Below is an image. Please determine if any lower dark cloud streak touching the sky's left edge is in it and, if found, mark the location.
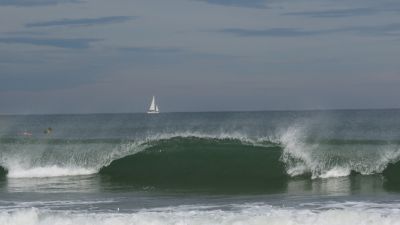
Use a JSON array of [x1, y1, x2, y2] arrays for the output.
[[0, 37, 100, 49]]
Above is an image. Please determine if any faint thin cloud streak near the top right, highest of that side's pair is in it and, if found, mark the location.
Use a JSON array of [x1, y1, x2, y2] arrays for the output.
[[283, 8, 379, 18]]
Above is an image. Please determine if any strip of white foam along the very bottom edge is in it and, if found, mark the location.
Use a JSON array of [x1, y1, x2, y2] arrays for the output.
[[0, 205, 400, 225]]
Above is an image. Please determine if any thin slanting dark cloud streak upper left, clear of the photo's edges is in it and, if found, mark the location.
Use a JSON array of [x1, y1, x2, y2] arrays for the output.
[[25, 16, 134, 27]]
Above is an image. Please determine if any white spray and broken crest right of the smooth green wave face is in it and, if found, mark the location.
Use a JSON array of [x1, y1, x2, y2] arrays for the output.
[[280, 127, 400, 179]]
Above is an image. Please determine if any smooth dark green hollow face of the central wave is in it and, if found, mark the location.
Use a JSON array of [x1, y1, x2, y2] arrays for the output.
[[100, 138, 288, 189]]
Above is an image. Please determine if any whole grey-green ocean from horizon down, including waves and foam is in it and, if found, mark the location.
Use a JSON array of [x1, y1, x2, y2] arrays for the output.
[[0, 110, 400, 225]]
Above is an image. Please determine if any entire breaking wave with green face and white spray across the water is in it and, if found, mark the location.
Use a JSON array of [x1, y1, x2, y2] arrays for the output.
[[0, 127, 400, 187]]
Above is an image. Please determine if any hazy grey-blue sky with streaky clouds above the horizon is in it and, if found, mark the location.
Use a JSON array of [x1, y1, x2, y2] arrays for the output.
[[0, 0, 400, 114]]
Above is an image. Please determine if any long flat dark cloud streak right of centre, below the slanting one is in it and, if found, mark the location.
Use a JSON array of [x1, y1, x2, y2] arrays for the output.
[[219, 28, 327, 37]]
